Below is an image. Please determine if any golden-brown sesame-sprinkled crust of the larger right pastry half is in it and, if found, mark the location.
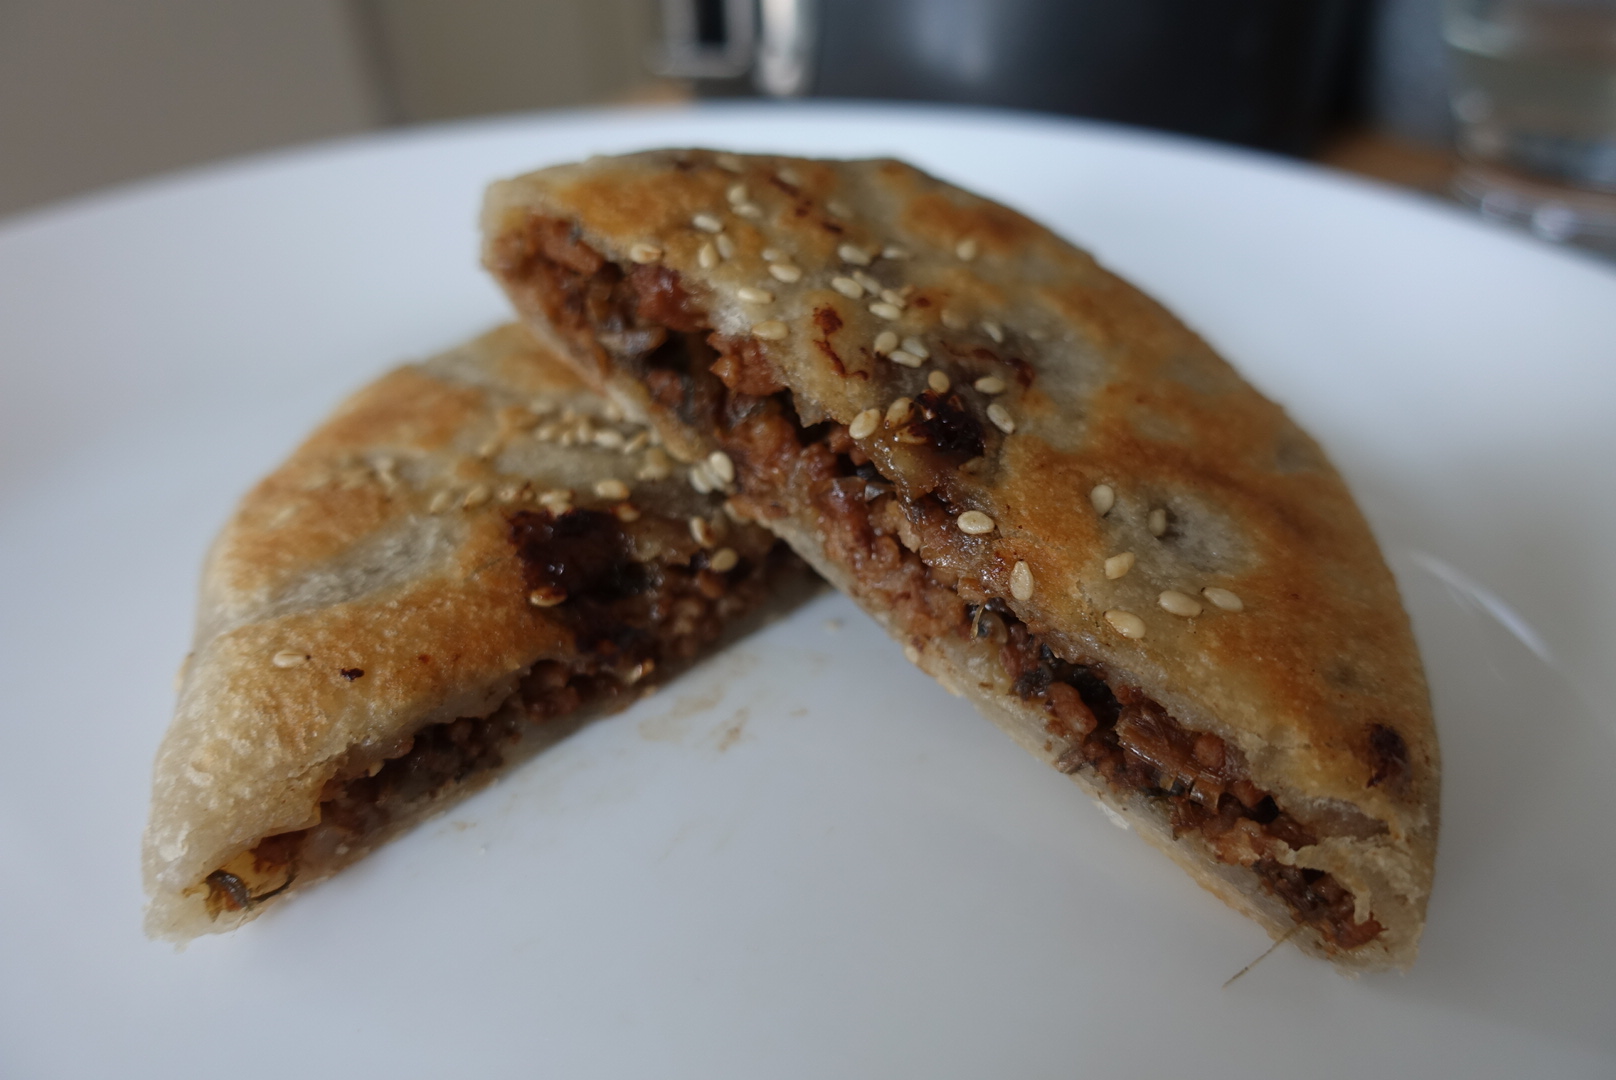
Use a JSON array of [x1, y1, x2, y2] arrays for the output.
[[483, 150, 1438, 967]]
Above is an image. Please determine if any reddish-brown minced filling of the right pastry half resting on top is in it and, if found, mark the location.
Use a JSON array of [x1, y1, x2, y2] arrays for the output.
[[493, 218, 1383, 951]]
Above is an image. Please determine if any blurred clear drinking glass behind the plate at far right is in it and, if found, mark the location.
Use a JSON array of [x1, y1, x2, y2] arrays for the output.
[[1443, 0, 1616, 255]]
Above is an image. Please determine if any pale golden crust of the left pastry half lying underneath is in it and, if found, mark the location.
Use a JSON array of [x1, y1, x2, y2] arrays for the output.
[[144, 327, 795, 939]]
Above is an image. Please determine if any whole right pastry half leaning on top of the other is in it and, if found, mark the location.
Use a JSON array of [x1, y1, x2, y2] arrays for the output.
[[483, 150, 1438, 968]]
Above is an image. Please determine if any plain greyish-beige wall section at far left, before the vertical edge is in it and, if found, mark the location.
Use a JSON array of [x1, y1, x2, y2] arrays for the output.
[[0, 0, 380, 213]]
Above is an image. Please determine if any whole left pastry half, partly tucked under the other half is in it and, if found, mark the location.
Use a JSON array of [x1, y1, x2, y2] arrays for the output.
[[144, 327, 811, 939]]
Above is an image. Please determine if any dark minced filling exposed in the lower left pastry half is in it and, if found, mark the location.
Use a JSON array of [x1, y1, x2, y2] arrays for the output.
[[204, 508, 800, 917]]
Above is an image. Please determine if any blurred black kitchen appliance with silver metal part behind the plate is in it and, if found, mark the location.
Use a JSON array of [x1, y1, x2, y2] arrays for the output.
[[663, 0, 1372, 154]]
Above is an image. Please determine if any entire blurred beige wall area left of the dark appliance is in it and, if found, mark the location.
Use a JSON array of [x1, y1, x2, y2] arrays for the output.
[[0, 0, 669, 215]]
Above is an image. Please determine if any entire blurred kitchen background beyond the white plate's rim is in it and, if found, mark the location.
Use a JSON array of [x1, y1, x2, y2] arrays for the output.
[[0, 0, 1616, 251]]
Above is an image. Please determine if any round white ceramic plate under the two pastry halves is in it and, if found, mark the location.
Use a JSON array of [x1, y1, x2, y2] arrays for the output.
[[0, 108, 1616, 1080]]
